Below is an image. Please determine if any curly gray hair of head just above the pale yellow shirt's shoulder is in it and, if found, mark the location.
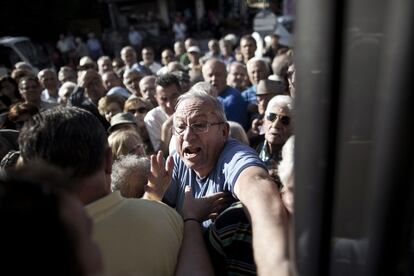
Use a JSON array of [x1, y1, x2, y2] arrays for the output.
[[111, 154, 151, 195]]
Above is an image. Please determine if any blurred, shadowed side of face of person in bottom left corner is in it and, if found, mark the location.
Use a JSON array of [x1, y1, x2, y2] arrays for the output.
[[60, 195, 103, 275]]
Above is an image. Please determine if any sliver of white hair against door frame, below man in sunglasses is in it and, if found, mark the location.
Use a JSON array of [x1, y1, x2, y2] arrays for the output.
[[277, 136, 295, 185]]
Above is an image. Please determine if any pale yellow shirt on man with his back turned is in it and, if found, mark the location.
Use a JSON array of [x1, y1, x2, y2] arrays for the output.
[[85, 191, 183, 276]]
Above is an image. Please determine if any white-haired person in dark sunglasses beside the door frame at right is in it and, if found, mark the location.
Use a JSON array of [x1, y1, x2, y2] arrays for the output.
[[255, 95, 293, 185]]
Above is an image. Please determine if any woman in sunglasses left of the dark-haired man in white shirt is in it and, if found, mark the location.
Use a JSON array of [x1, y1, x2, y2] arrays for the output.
[[124, 96, 154, 155]]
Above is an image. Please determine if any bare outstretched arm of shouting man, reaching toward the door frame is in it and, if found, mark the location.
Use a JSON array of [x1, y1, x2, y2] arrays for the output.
[[234, 166, 289, 275]]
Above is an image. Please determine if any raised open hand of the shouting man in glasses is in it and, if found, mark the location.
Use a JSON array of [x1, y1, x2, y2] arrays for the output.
[[143, 151, 174, 201]]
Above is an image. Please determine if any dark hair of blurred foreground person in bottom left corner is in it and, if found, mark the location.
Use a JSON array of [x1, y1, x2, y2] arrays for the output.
[[0, 166, 82, 276]]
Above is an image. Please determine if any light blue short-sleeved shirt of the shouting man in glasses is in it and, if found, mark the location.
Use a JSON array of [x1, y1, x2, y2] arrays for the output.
[[164, 138, 266, 226]]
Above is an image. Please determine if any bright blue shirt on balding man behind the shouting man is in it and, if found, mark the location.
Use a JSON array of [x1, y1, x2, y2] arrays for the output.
[[217, 86, 250, 130]]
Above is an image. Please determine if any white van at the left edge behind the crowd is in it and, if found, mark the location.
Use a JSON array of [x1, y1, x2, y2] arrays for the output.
[[0, 36, 52, 76]]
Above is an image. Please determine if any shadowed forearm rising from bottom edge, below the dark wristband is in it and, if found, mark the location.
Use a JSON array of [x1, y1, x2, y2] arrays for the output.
[[175, 220, 214, 276]]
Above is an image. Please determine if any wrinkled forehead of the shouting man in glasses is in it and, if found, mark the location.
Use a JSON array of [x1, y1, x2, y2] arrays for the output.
[[174, 99, 216, 121]]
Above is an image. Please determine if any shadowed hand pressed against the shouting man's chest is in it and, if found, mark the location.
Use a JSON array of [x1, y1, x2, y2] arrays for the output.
[[183, 186, 231, 221]]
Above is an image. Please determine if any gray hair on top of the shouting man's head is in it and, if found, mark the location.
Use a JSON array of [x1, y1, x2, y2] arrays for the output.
[[175, 85, 227, 122]]
